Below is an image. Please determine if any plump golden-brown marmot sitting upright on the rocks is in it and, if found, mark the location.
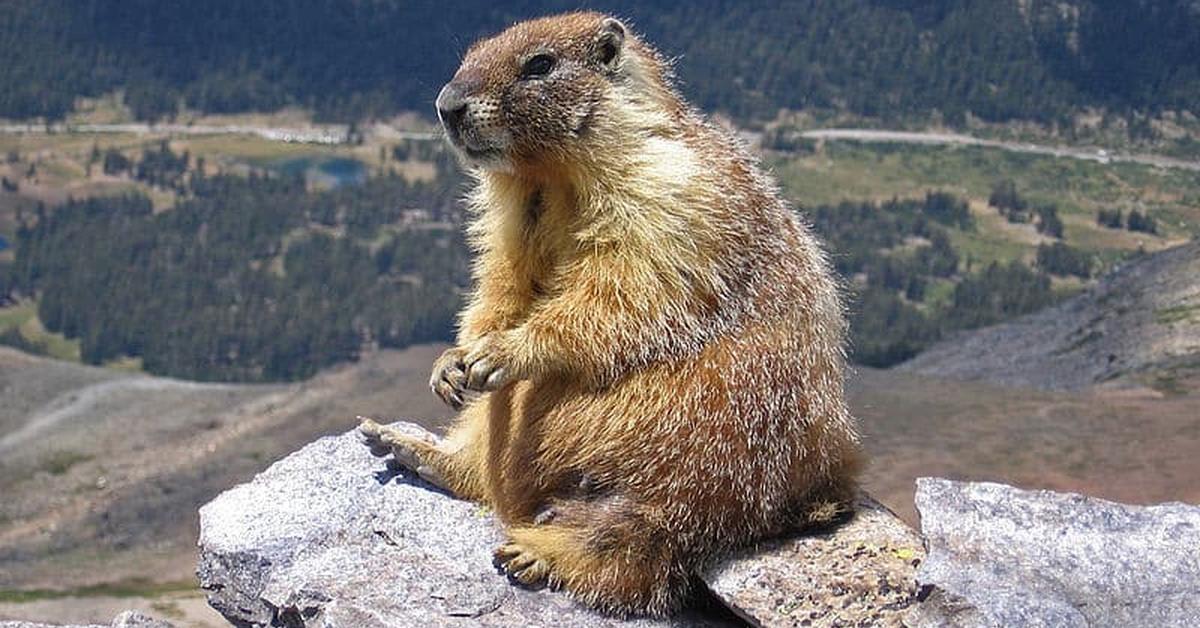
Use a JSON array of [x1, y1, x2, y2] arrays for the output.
[[362, 12, 860, 615]]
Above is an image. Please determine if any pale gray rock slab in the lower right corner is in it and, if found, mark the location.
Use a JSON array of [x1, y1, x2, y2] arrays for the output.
[[907, 478, 1200, 628]]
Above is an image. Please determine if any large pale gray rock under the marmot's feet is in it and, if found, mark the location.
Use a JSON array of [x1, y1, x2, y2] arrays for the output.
[[198, 425, 721, 628]]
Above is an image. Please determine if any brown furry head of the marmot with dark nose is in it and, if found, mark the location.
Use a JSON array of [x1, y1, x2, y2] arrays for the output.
[[437, 13, 677, 169]]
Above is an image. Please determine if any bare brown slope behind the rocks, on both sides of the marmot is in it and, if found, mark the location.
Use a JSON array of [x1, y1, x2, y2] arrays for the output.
[[0, 338, 1200, 626]]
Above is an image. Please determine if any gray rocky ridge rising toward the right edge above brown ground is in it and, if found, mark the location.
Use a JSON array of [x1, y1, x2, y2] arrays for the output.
[[898, 241, 1200, 390]]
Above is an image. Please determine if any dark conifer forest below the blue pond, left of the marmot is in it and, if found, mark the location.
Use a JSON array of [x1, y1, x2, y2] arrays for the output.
[[8, 146, 469, 382]]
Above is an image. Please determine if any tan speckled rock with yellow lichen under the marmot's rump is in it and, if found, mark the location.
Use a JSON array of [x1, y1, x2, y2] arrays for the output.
[[703, 497, 925, 627]]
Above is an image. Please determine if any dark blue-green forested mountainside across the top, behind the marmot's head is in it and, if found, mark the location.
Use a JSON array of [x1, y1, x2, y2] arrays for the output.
[[0, 0, 1200, 122]]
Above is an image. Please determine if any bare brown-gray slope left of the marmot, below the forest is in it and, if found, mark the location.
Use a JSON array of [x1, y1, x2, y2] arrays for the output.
[[0, 346, 449, 590]]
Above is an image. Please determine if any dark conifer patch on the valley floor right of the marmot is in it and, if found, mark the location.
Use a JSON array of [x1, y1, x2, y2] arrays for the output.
[[806, 192, 1069, 367]]
